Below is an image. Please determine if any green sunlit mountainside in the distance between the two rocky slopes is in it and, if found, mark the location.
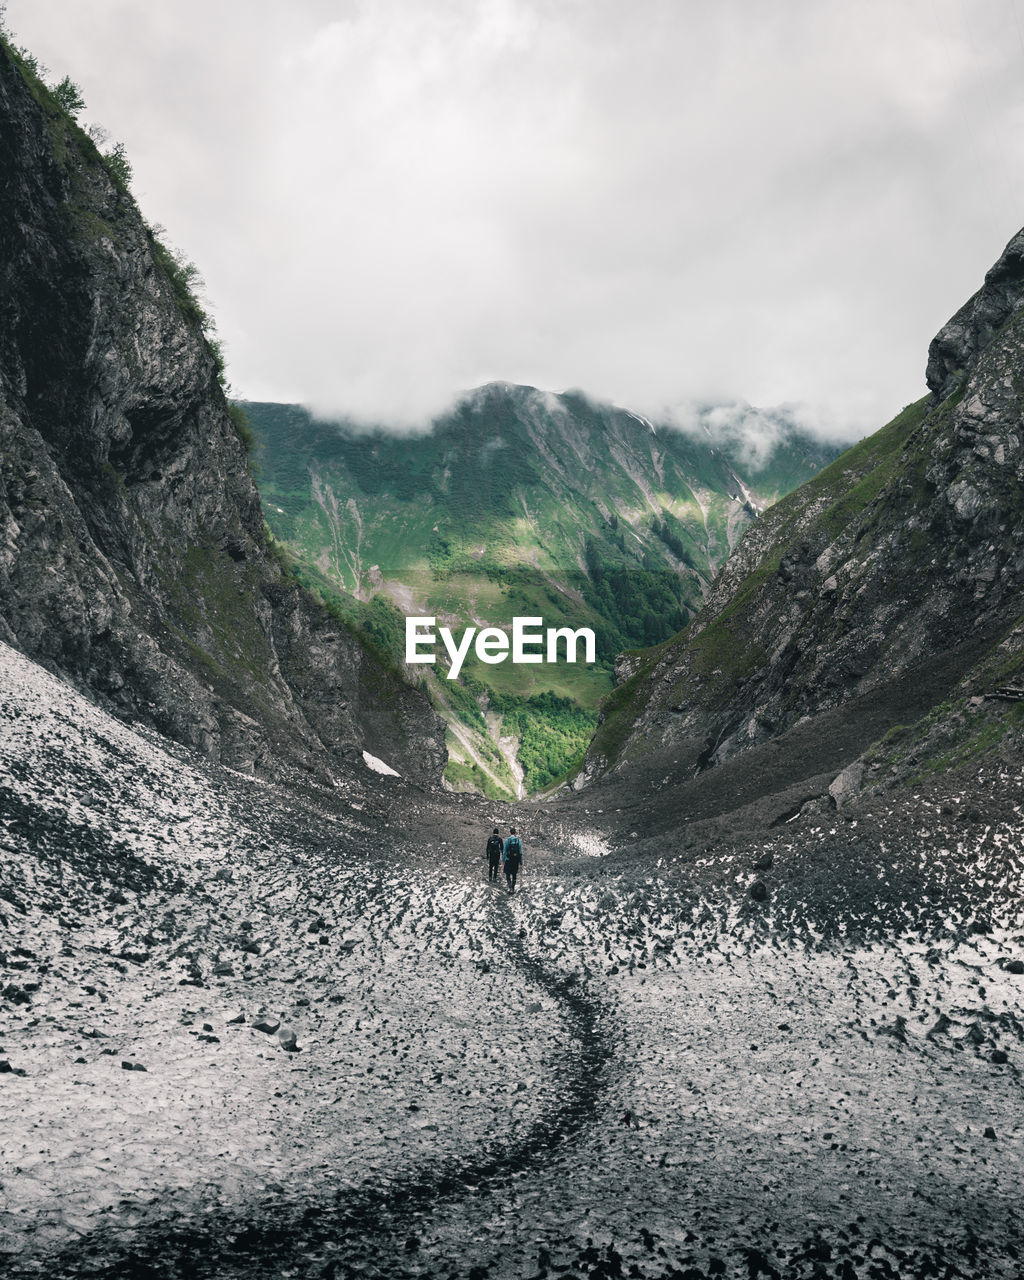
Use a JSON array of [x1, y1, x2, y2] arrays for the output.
[[244, 384, 838, 794]]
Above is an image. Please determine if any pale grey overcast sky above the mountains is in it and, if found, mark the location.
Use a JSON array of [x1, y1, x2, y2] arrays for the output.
[[6, 0, 1024, 435]]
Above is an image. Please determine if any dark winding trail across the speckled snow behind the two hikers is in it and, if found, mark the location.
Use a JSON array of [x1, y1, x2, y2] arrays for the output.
[[32, 880, 616, 1280]]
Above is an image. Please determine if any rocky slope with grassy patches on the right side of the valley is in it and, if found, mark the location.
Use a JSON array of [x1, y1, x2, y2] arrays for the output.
[[582, 218, 1024, 787]]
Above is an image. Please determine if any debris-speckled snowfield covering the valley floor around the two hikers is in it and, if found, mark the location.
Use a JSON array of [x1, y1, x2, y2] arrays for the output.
[[0, 645, 1024, 1280]]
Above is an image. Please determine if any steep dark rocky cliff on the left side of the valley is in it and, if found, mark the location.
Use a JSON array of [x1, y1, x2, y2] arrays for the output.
[[0, 47, 445, 781]]
